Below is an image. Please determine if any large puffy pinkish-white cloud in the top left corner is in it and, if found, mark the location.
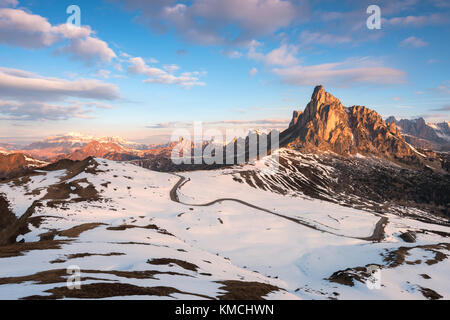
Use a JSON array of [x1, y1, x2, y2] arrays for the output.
[[0, 8, 116, 64]]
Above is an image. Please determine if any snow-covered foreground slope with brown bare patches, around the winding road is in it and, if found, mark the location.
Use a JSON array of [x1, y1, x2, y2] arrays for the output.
[[0, 159, 450, 299]]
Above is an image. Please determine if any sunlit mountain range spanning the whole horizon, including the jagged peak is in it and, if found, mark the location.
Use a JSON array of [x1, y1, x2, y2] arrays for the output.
[[0, 86, 450, 178]]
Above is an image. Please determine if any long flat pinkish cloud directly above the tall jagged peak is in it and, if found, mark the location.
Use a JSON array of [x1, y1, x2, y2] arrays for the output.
[[273, 58, 406, 87]]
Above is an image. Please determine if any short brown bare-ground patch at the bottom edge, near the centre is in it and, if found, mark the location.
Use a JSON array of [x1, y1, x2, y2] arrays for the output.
[[217, 280, 282, 300]]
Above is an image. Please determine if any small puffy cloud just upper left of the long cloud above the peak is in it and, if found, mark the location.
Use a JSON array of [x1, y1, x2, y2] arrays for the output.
[[247, 43, 299, 66]]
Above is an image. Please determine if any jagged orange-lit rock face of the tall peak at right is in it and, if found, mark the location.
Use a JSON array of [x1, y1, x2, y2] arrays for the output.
[[280, 86, 419, 162]]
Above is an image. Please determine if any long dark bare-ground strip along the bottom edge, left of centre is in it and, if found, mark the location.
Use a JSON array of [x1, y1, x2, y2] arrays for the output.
[[24, 283, 213, 300]]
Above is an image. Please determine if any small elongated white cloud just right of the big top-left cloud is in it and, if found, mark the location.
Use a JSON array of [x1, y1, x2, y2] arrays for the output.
[[128, 57, 206, 88]]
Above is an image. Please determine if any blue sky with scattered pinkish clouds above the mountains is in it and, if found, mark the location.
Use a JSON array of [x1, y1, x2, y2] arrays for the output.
[[0, 0, 450, 143]]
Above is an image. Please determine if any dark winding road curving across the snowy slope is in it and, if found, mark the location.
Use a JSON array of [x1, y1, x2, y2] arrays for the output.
[[170, 173, 389, 242]]
